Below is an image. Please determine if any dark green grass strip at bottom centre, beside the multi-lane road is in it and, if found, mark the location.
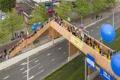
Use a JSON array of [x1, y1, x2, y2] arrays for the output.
[[44, 55, 84, 80]]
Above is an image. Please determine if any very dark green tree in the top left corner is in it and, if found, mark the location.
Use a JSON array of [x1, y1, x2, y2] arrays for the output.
[[0, 0, 16, 12]]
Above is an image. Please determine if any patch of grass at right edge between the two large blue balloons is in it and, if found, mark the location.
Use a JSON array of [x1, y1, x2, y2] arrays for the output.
[[106, 28, 120, 51]]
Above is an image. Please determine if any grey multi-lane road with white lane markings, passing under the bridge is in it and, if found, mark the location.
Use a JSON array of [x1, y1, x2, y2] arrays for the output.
[[0, 41, 68, 80]]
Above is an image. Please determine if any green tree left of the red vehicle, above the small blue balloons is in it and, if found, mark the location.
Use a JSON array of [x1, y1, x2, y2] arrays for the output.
[[28, 4, 48, 24]]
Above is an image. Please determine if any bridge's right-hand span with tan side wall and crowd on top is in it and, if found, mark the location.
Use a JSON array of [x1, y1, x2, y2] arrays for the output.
[[50, 18, 120, 80]]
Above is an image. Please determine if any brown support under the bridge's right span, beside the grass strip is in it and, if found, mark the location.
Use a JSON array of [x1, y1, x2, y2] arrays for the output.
[[68, 42, 80, 61]]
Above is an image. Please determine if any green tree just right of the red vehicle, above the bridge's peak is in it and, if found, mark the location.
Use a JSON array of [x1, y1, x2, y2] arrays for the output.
[[55, 0, 72, 19]]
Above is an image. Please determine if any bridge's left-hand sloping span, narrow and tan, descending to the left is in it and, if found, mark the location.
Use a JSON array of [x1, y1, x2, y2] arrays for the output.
[[9, 20, 50, 58]]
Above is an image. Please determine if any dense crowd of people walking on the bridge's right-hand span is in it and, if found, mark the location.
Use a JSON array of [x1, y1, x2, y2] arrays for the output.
[[55, 16, 114, 59]]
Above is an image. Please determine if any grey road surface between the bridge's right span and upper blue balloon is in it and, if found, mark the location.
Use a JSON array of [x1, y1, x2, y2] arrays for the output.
[[86, 13, 120, 40]]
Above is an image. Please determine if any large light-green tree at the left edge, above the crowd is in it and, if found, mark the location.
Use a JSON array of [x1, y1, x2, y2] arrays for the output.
[[1, 9, 23, 32]]
